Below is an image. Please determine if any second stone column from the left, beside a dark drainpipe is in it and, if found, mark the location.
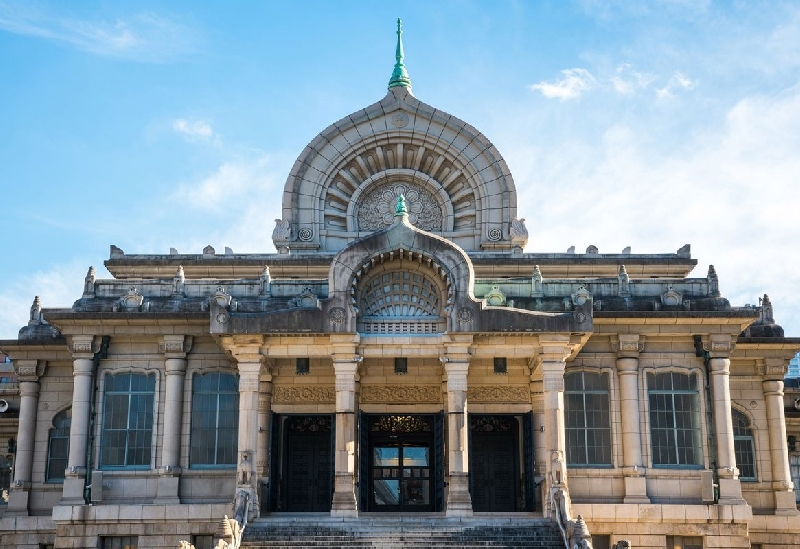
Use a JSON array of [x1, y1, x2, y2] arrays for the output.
[[60, 335, 94, 505]]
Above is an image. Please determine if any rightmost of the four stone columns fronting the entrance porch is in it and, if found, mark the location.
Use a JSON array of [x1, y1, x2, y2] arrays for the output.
[[539, 335, 570, 512]]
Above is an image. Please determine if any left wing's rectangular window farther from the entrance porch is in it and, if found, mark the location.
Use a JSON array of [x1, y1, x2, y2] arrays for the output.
[[100, 373, 156, 468]]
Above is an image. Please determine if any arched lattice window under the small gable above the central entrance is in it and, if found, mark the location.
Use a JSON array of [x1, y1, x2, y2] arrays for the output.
[[356, 262, 446, 334]]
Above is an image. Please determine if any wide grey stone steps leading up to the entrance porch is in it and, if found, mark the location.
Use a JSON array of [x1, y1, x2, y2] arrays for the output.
[[241, 516, 564, 549]]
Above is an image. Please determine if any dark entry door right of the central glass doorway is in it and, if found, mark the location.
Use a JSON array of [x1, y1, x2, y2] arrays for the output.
[[469, 418, 519, 512]]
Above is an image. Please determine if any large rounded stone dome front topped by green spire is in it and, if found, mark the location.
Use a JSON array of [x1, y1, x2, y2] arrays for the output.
[[273, 21, 527, 252]]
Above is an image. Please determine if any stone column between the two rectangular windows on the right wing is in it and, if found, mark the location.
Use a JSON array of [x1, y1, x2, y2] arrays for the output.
[[611, 334, 650, 503]]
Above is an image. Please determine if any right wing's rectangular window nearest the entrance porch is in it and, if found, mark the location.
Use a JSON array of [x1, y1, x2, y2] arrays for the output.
[[564, 372, 611, 466]]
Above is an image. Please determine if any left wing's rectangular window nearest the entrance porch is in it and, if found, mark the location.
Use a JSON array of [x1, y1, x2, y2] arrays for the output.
[[189, 372, 239, 467]]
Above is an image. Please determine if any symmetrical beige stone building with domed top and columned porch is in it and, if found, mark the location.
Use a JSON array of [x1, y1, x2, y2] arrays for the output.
[[0, 23, 800, 549]]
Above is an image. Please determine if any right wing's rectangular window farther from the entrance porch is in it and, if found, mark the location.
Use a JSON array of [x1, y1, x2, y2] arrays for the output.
[[647, 372, 703, 467]]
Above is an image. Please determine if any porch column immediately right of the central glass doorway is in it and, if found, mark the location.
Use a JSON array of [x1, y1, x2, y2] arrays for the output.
[[442, 354, 472, 517]]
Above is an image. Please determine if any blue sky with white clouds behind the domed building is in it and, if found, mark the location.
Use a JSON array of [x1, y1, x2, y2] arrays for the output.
[[0, 0, 800, 339]]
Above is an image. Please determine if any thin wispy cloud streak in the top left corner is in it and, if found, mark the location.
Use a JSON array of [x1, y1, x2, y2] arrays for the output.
[[0, 2, 196, 63]]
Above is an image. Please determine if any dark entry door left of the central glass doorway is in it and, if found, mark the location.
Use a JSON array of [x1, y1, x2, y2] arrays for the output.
[[284, 418, 333, 513]]
